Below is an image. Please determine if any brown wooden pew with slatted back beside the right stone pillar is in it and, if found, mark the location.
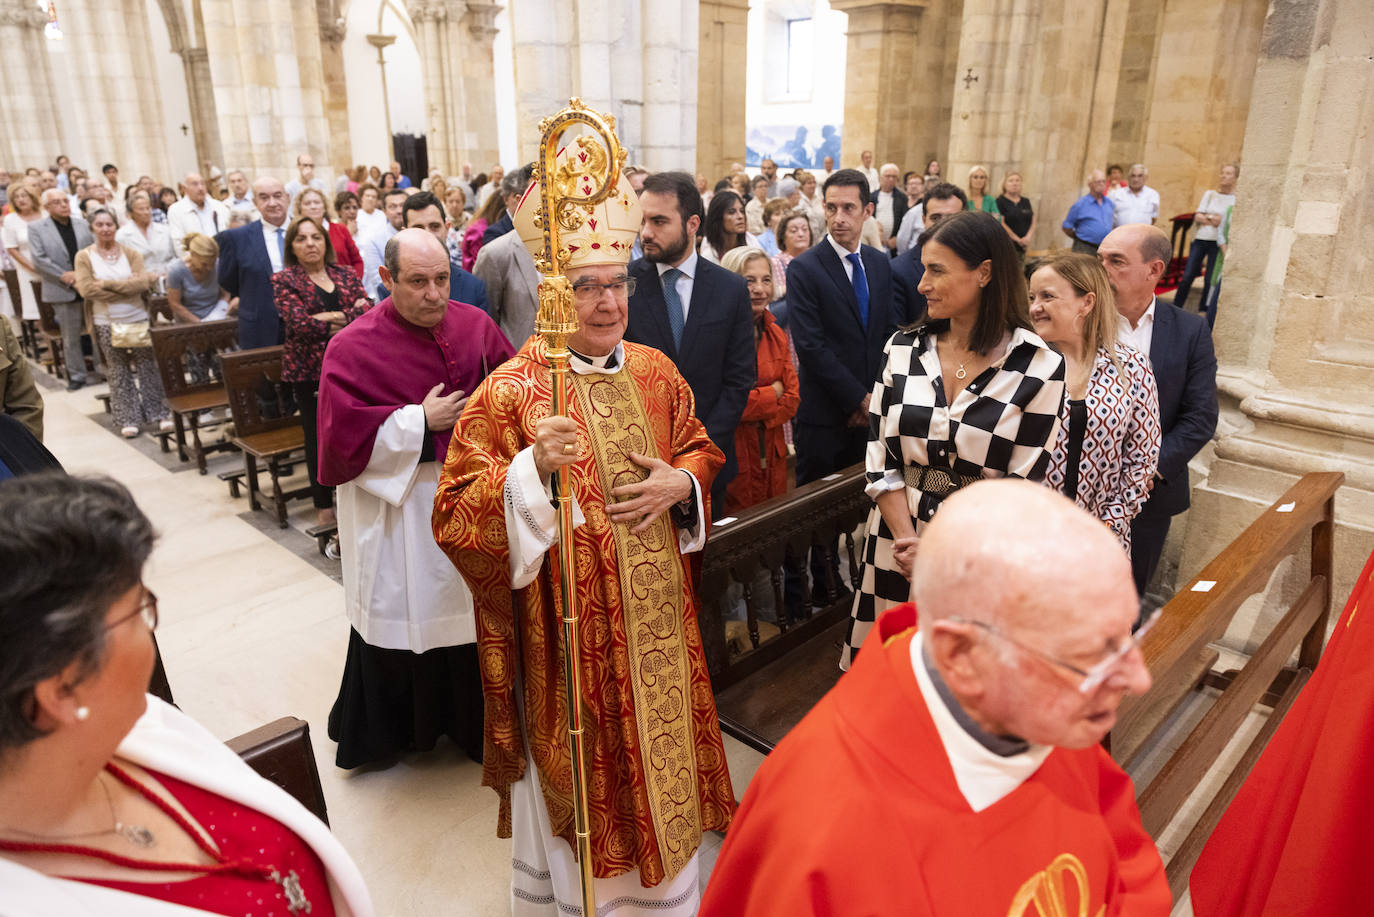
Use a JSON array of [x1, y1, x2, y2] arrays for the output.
[[1112, 473, 1345, 898]]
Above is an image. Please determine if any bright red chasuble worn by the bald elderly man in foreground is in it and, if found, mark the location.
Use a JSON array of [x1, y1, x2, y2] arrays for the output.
[[699, 602, 1171, 917]]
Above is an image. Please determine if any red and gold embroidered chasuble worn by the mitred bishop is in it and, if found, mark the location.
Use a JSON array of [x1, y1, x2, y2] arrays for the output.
[[434, 337, 734, 887]]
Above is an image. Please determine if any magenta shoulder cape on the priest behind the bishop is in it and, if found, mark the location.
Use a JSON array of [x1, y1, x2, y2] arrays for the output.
[[319, 297, 514, 487]]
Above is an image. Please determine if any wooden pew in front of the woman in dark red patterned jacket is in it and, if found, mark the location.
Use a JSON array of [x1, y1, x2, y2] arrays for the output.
[[220, 345, 309, 528]]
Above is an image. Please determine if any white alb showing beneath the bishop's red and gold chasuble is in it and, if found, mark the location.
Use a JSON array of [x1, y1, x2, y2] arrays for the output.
[[506, 344, 706, 917]]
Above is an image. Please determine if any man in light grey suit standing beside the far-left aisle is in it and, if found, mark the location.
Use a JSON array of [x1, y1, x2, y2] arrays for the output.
[[29, 188, 99, 392]]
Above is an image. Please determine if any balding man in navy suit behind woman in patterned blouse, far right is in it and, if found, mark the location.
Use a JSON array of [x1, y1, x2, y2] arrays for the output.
[[1098, 224, 1217, 595]]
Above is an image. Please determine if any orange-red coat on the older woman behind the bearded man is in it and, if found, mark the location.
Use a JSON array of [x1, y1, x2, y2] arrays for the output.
[[725, 311, 801, 513]]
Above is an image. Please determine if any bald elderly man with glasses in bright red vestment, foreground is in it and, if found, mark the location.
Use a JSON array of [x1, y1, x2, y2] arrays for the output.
[[701, 480, 1171, 917]]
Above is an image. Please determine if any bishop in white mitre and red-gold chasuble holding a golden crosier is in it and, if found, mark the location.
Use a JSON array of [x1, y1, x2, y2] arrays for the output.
[[434, 150, 734, 917]]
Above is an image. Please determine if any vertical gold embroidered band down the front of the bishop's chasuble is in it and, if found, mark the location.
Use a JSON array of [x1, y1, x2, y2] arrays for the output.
[[573, 368, 702, 876]]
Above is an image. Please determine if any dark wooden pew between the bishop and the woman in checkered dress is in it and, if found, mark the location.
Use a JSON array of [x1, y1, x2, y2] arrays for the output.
[[698, 465, 872, 753]]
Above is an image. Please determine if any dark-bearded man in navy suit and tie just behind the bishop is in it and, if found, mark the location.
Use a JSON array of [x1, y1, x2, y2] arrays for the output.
[[625, 172, 758, 518]]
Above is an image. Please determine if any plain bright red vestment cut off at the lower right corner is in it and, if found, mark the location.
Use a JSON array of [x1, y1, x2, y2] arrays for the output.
[[1189, 557, 1374, 917]]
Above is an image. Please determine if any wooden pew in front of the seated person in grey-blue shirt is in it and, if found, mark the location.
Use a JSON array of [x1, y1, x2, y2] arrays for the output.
[[151, 318, 239, 474]]
